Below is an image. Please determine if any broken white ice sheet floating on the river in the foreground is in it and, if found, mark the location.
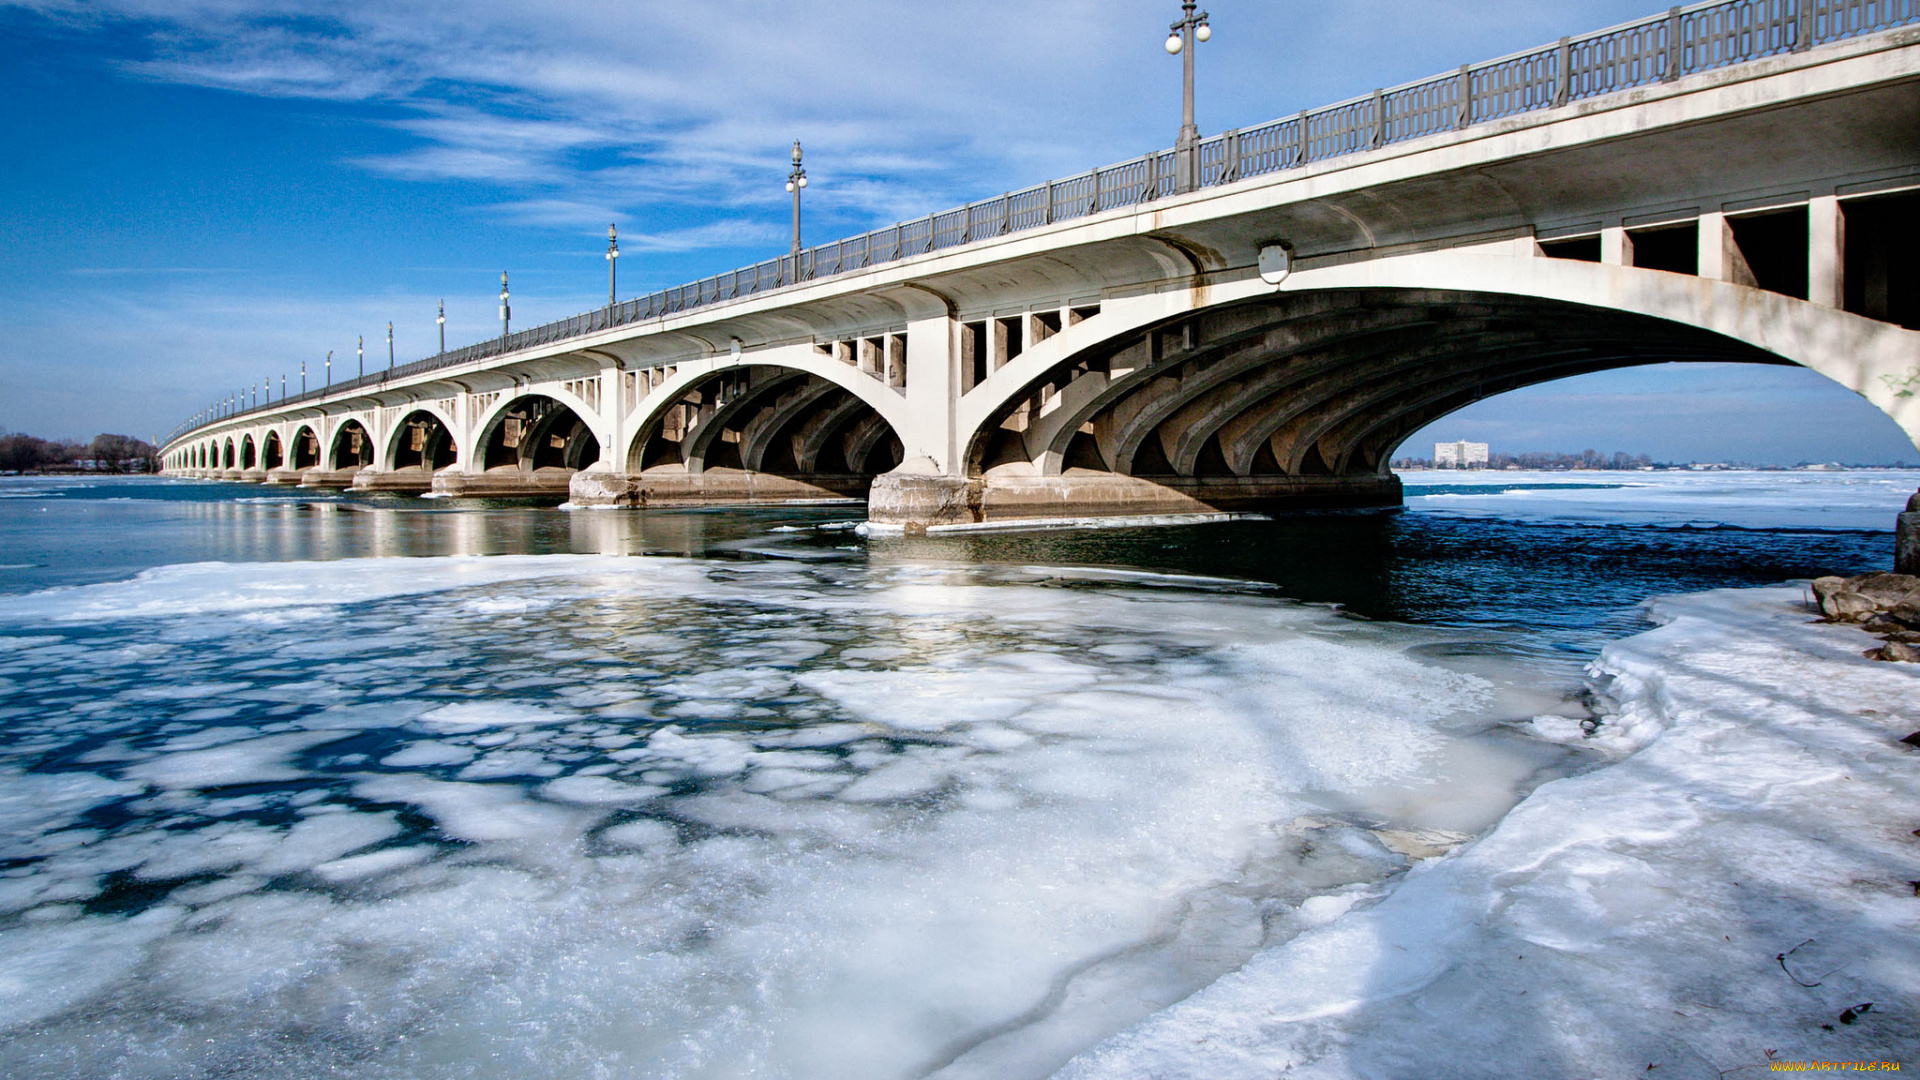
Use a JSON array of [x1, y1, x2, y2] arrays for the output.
[[0, 557, 1589, 1080]]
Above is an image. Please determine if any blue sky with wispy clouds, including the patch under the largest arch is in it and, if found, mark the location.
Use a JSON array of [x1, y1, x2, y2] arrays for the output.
[[0, 0, 1920, 463]]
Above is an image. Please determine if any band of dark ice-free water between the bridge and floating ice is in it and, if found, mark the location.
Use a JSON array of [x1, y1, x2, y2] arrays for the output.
[[0, 479, 1903, 653]]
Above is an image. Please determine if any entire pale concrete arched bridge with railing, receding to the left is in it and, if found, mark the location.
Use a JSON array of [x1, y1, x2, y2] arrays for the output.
[[163, 0, 1920, 527]]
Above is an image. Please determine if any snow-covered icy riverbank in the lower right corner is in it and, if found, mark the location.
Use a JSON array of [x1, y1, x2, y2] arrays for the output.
[[1060, 588, 1920, 1080]]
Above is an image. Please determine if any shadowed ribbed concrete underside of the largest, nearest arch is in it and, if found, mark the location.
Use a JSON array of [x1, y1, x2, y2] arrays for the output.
[[966, 288, 1789, 484]]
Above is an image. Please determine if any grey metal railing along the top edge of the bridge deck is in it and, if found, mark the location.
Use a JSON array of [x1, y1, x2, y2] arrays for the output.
[[167, 0, 1920, 444]]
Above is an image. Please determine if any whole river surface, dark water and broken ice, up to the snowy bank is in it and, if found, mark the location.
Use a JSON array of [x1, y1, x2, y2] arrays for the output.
[[0, 473, 1920, 1078]]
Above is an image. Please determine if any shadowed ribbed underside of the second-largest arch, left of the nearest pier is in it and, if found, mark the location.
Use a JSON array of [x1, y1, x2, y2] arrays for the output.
[[626, 365, 902, 494]]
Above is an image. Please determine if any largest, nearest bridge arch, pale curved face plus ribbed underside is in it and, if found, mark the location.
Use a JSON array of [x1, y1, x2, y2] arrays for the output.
[[962, 252, 1920, 486]]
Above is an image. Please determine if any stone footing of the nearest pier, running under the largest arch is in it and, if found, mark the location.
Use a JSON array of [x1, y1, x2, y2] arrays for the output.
[[866, 465, 1402, 530]]
